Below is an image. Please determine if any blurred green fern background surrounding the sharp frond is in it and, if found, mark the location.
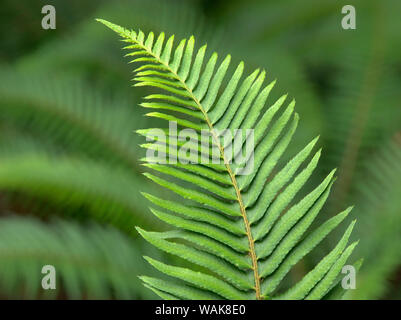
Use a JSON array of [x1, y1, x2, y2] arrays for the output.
[[0, 0, 401, 299]]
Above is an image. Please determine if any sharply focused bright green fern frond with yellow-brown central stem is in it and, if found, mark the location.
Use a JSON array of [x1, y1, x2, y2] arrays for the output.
[[98, 19, 357, 300]]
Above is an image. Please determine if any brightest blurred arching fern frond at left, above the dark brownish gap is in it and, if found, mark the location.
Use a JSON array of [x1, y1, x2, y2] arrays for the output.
[[0, 151, 156, 233]]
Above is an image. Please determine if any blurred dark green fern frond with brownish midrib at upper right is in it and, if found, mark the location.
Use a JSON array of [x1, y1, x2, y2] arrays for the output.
[[325, 2, 401, 212]]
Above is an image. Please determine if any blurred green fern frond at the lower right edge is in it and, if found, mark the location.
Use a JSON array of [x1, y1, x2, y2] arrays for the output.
[[347, 138, 401, 299]]
